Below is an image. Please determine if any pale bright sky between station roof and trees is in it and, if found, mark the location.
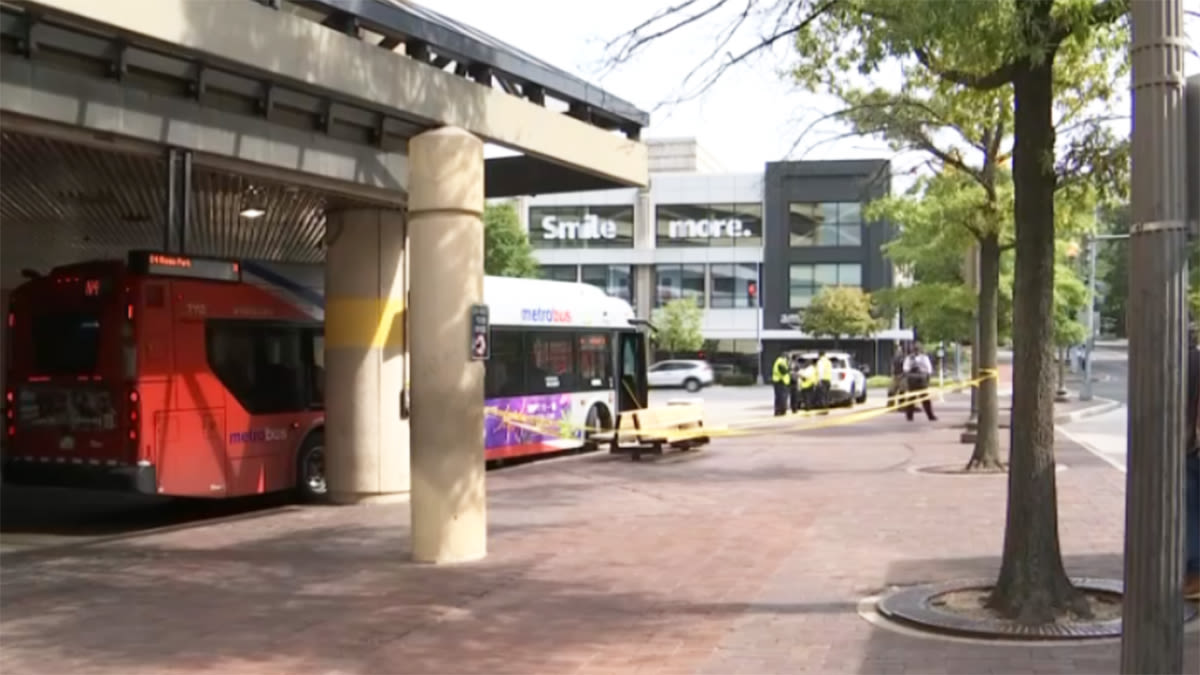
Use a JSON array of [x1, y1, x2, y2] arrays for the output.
[[436, 0, 1200, 181]]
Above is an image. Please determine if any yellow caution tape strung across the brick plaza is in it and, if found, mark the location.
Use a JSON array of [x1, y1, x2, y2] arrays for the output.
[[484, 369, 1000, 442]]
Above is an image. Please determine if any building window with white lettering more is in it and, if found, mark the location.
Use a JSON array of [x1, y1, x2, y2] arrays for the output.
[[655, 203, 762, 247]]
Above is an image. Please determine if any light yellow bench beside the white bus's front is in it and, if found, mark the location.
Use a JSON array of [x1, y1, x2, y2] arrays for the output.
[[592, 404, 709, 461]]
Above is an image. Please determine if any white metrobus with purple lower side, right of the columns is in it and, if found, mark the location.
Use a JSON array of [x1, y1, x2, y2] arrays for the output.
[[242, 262, 647, 461]]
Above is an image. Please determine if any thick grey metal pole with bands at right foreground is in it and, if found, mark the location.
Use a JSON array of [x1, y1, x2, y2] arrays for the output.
[[1121, 0, 1187, 674]]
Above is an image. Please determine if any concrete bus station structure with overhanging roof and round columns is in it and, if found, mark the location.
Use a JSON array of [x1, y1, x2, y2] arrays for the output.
[[0, 0, 648, 562]]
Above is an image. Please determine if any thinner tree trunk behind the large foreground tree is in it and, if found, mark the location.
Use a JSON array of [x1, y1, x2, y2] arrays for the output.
[[967, 234, 1004, 471]]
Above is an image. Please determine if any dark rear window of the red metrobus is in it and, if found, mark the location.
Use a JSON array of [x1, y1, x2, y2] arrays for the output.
[[30, 311, 101, 375]]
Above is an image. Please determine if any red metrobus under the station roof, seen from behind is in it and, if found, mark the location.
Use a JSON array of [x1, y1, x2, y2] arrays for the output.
[[4, 251, 325, 497]]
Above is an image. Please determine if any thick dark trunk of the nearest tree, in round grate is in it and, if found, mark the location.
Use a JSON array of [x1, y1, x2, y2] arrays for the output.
[[989, 48, 1088, 625]]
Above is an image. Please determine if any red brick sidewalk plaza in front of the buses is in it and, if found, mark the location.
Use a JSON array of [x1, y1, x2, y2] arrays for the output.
[[0, 416, 1200, 674]]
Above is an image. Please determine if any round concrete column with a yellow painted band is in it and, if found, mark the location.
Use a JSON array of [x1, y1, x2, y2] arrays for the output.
[[325, 209, 409, 503]]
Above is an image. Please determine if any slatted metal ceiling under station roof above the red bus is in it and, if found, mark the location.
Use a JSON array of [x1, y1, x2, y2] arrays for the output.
[[0, 131, 346, 287]]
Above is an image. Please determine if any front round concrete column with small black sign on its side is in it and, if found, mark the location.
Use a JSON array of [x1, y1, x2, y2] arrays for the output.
[[408, 127, 487, 562]]
